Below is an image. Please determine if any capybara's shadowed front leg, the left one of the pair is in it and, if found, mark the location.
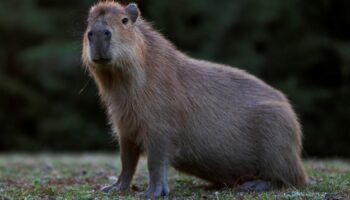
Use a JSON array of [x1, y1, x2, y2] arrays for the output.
[[102, 137, 141, 192]]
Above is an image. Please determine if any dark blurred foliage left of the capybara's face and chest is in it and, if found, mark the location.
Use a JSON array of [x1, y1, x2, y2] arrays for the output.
[[0, 0, 110, 150]]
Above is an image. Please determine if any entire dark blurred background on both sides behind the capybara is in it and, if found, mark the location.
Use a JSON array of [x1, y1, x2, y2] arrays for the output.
[[0, 0, 350, 157]]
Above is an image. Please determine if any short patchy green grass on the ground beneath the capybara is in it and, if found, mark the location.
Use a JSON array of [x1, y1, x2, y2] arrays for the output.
[[0, 154, 350, 200]]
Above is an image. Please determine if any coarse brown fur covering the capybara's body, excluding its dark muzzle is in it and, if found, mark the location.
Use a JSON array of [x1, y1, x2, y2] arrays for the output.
[[83, 2, 307, 196]]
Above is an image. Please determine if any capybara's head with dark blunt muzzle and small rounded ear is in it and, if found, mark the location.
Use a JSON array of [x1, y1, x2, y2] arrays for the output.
[[83, 1, 142, 67]]
